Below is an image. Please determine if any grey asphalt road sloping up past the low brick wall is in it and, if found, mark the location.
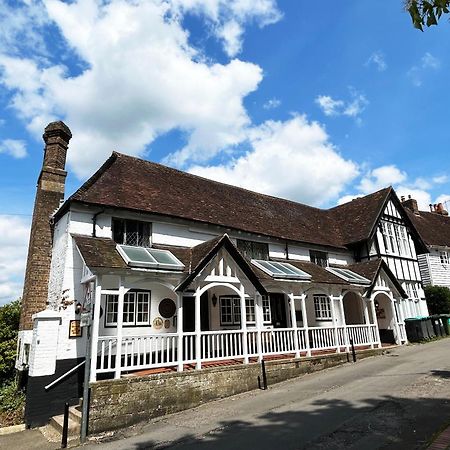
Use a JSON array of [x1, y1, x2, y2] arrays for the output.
[[82, 339, 450, 450]]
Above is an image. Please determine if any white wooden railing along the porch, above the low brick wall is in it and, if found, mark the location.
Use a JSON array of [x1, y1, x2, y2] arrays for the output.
[[96, 324, 382, 374]]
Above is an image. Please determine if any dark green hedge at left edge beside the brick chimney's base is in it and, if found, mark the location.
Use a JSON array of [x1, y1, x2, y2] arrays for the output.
[[0, 300, 20, 386]]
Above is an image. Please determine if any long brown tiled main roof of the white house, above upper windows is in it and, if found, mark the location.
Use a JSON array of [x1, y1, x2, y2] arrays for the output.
[[61, 152, 391, 248]]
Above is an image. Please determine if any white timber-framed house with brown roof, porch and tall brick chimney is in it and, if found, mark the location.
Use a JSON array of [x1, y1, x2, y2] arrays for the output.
[[17, 122, 428, 426]]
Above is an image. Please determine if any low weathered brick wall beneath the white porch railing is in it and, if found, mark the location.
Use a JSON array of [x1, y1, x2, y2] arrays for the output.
[[89, 349, 383, 434]]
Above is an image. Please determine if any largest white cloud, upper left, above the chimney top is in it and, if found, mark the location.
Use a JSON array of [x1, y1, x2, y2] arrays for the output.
[[0, 0, 275, 177]]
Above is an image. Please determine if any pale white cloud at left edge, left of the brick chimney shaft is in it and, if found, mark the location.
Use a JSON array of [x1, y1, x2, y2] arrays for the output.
[[0, 216, 29, 305]]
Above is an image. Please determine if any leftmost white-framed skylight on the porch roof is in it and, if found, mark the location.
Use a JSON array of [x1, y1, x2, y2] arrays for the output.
[[117, 245, 184, 270]]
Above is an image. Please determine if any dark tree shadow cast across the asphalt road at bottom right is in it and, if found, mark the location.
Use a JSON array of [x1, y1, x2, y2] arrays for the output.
[[100, 394, 450, 450]]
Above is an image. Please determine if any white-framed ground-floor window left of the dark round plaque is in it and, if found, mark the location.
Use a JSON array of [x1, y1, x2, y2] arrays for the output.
[[105, 291, 150, 326]]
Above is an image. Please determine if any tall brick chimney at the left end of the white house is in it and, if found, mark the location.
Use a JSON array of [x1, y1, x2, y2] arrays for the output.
[[20, 122, 72, 330]]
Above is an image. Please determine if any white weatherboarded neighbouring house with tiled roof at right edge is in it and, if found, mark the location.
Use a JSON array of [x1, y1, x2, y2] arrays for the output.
[[402, 197, 450, 288]]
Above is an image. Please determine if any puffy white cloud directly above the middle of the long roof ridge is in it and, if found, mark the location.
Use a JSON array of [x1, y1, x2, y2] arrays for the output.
[[189, 116, 358, 206]]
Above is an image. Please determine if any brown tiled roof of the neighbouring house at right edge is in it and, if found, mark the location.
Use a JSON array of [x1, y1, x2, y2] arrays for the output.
[[407, 210, 450, 247]]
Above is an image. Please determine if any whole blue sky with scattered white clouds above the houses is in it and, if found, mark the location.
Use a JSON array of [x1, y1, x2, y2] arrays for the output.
[[0, 0, 450, 304]]
